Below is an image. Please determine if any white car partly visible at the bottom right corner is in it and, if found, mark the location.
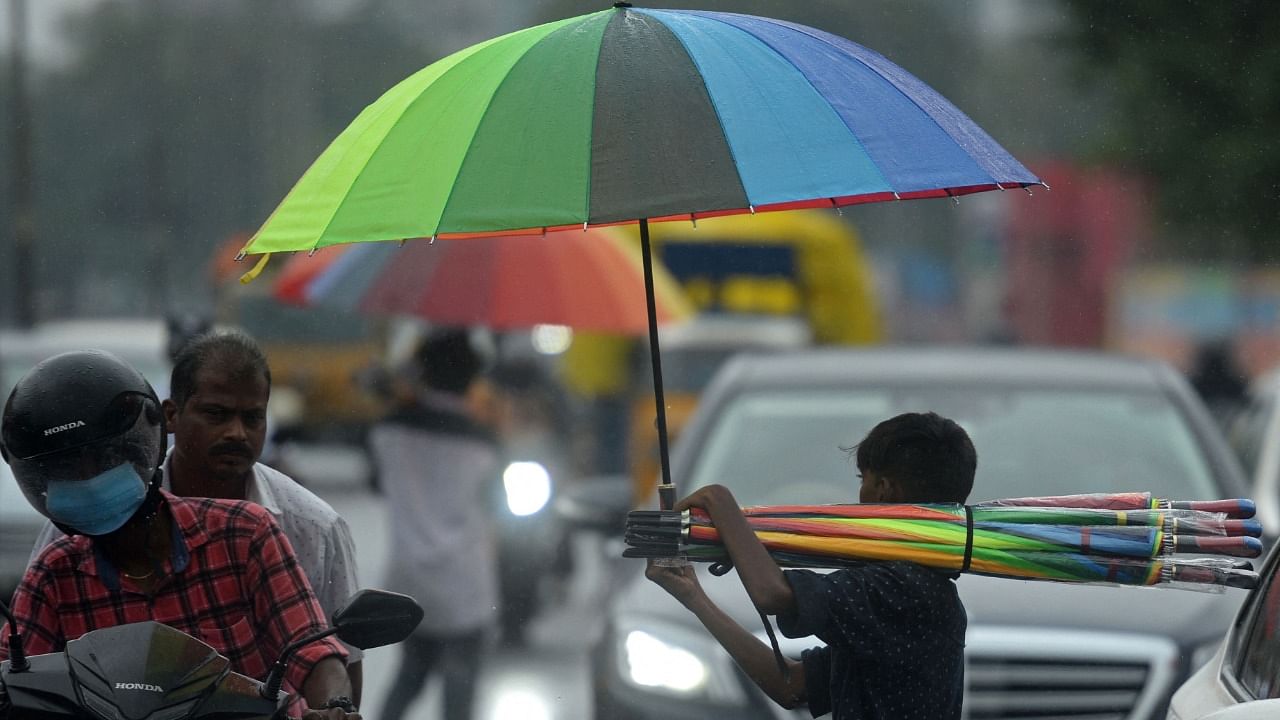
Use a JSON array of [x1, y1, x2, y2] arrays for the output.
[[1169, 535, 1280, 720]]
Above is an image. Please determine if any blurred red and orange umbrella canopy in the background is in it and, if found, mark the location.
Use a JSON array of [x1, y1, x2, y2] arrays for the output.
[[273, 228, 692, 334]]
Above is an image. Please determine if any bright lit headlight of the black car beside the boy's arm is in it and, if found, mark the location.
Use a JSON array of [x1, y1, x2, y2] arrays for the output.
[[614, 620, 746, 706]]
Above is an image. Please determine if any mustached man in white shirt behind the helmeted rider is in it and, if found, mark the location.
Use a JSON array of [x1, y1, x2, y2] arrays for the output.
[[35, 332, 364, 706]]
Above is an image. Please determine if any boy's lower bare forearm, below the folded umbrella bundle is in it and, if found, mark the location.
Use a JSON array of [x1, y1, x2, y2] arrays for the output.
[[645, 560, 806, 708]]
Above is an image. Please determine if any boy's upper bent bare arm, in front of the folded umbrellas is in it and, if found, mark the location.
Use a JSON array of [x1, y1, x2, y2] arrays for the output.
[[675, 486, 796, 615]]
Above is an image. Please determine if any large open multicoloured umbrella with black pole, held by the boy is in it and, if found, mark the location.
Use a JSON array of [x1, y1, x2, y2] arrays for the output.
[[243, 3, 1041, 505]]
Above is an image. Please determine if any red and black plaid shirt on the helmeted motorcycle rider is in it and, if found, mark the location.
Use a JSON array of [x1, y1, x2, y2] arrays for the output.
[[0, 492, 346, 688]]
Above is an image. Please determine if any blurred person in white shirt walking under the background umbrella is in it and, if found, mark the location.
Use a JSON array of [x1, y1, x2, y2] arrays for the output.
[[369, 329, 499, 720]]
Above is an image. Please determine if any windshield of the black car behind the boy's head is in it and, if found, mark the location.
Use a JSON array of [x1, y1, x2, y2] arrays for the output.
[[690, 387, 1221, 505]]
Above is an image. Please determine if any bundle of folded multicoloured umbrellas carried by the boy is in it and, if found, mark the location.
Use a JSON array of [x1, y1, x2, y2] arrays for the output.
[[623, 492, 1262, 589]]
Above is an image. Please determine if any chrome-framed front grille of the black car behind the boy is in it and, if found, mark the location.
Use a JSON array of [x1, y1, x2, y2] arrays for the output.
[[965, 626, 1178, 720]]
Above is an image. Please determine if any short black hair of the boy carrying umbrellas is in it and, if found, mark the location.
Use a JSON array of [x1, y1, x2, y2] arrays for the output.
[[845, 413, 978, 503]]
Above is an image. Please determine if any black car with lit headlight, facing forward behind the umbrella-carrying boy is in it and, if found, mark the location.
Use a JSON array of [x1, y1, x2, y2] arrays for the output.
[[591, 348, 1247, 720]]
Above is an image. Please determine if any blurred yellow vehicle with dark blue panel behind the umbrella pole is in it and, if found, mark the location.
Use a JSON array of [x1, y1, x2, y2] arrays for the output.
[[564, 204, 883, 505]]
